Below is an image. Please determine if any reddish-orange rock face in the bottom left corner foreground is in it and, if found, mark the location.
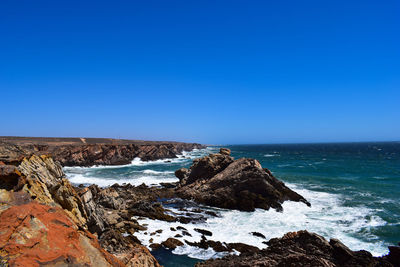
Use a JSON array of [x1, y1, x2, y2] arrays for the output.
[[0, 202, 123, 266]]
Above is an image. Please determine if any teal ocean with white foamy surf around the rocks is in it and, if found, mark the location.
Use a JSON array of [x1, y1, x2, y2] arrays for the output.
[[64, 142, 400, 266]]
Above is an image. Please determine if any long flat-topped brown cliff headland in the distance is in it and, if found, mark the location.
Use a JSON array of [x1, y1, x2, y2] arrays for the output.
[[0, 137, 204, 166]]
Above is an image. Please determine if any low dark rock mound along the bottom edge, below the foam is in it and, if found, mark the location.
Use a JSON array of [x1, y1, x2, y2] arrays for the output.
[[196, 231, 396, 267]]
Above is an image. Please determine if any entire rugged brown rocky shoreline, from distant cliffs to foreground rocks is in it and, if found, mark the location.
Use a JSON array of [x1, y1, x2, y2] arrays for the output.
[[0, 138, 400, 266]]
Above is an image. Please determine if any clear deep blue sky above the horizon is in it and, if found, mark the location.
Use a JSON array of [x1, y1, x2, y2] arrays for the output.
[[0, 0, 400, 144]]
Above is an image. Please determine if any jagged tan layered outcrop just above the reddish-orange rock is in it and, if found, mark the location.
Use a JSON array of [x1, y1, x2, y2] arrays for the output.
[[0, 146, 86, 228]]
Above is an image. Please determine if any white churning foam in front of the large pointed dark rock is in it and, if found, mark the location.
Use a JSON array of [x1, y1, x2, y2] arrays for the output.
[[135, 185, 387, 259]]
